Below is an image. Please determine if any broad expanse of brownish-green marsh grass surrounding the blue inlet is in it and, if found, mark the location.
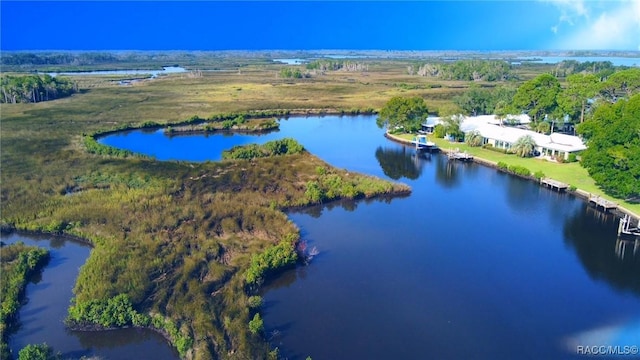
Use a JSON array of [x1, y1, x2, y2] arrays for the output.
[[0, 58, 568, 359]]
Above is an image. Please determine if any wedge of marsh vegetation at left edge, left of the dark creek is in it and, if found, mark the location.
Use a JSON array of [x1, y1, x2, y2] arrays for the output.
[[0, 243, 49, 360]]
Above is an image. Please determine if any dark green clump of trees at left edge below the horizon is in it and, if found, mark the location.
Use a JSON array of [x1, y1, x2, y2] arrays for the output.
[[0, 75, 78, 104]]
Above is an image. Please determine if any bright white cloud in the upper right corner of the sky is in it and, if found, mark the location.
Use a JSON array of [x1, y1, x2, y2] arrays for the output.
[[546, 0, 640, 50]]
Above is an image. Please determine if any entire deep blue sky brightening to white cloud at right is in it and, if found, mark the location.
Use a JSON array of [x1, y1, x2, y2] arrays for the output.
[[0, 0, 640, 50]]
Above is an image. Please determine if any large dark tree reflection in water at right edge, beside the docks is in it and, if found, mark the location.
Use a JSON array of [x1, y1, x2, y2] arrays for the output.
[[564, 204, 640, 295]]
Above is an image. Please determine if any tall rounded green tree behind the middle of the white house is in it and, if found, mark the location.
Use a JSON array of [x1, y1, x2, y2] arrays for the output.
[[513, 74, 560, 122]]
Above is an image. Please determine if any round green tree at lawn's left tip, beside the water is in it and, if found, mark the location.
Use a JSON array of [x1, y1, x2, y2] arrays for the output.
[[376, 96, 429, 132]]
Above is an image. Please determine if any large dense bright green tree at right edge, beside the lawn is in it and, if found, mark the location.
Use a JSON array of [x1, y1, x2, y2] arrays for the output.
[[578, 94, 640, 202]]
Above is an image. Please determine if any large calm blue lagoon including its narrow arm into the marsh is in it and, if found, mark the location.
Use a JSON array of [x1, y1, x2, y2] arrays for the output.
[[96, 116, 640, 359]]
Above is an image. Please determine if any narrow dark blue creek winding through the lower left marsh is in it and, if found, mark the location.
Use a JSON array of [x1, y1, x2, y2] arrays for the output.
[[2, 234, 179, 360]]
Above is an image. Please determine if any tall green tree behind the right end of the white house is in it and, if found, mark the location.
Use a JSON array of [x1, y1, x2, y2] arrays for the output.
[[558, 73, 600, 122]]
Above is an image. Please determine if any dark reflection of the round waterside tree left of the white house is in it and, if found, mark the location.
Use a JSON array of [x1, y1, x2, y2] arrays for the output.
[[376, 146, 426, 180]]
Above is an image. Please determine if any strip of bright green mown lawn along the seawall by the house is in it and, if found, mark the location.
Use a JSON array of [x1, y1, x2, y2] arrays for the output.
[[397, 134, 640, 214]]
